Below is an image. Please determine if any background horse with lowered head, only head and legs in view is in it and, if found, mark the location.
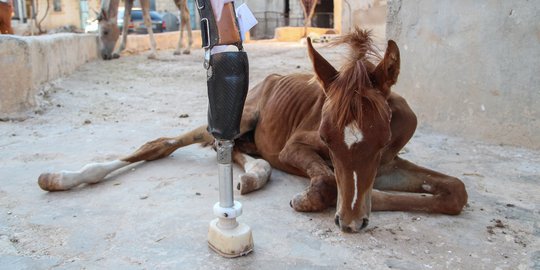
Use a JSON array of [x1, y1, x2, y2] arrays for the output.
[[98, 0, 193, 60]]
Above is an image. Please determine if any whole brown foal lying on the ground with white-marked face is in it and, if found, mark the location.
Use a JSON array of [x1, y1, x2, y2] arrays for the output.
[[38, 29, 467, 232]]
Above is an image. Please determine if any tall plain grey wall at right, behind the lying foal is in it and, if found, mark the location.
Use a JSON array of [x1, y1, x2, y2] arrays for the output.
[[386, 0, 540, 149]]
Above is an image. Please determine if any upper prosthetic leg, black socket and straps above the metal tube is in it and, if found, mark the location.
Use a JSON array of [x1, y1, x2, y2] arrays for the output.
[[197, 0, 249, 140]]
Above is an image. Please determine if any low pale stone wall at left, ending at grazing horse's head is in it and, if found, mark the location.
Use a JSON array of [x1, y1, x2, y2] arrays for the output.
[[0, 34, 98, 119]]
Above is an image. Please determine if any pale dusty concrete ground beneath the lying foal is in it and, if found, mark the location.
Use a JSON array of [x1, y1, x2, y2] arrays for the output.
[[0, 43, 540, 269]]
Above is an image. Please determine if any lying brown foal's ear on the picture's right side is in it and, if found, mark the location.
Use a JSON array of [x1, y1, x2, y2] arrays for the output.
[[373, 40, 400, 97]]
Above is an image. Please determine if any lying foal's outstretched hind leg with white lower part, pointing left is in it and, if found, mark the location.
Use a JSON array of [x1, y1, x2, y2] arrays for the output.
[[38, 126, 214, 191]]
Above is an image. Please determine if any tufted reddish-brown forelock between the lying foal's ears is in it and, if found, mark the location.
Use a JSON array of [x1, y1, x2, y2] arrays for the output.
[[323, 28, 390, 130]]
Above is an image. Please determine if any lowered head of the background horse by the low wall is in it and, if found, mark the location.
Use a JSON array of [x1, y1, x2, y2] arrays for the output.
[[97, 8, 120, 60]]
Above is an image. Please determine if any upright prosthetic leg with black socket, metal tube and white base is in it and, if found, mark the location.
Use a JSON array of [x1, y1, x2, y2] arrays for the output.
[[197, 0, 253, 257]]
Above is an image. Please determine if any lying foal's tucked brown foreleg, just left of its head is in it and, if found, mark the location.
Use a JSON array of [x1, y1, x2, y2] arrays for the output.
[[279, 131, 337, 212]]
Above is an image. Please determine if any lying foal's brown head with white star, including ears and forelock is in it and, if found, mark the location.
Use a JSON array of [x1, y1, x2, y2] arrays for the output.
[[308, 29, 400, 232]]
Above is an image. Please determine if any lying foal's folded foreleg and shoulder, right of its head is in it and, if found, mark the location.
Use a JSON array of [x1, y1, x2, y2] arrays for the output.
[[372, 94, 467, 214]]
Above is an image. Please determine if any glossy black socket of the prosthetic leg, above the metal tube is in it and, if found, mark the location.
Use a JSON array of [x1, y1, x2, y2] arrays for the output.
[[207, 51, 249, 140]]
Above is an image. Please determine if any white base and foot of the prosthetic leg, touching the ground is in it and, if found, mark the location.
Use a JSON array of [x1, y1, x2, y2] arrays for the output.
[[208, 201, 253, 258]]
